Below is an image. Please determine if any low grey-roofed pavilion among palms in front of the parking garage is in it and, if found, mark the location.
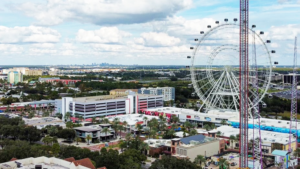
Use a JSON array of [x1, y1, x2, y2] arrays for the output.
[[74, 124, 115, 142]]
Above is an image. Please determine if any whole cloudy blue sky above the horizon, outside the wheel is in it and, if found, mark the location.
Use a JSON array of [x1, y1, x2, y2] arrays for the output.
[[0, 0, 300, 65]]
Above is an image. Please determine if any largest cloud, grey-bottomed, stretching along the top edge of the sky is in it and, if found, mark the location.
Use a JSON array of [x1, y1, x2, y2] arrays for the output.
[[12, 0, 192, 25]]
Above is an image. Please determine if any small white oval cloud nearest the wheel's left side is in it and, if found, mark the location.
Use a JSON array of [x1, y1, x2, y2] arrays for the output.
[[136, 32, 180, 47]]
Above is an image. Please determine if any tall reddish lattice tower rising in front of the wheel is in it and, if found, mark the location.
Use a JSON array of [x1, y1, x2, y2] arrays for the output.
[[239, 0, 249, 169]]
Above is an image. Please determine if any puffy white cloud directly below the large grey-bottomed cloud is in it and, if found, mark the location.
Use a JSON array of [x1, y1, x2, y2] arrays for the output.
[[76, 27, 131, 43]]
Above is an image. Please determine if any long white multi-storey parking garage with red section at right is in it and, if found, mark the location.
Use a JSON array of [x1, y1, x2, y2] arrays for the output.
[[55, 94, 163, 119]]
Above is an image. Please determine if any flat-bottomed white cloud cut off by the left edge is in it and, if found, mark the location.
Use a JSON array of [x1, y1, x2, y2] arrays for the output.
[[0, 26, 61, 43]]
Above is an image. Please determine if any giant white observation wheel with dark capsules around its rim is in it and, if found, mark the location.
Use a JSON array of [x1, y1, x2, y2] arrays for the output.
[[188, 19, 275, 114]]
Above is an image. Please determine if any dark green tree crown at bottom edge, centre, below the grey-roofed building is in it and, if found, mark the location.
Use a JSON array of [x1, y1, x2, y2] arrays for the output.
[[149, 155, 201, 169]]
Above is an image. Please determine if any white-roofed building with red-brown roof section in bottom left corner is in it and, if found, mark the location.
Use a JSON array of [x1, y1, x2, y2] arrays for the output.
[[0, 156, 95, 169]]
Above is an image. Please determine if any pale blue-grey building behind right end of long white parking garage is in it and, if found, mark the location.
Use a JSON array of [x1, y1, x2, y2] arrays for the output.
[[138, 87, 175, 101]]
